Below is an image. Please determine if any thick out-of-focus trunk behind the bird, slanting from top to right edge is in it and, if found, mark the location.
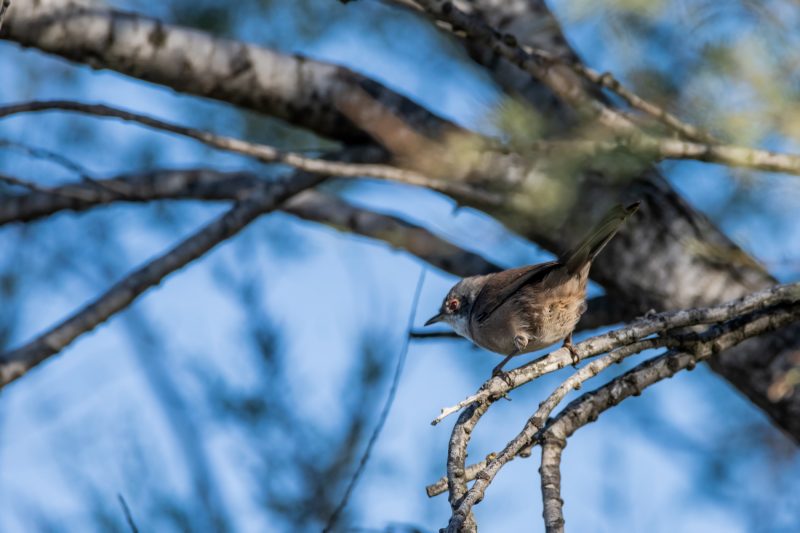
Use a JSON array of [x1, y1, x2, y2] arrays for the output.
[[444, 0, 800, 441]]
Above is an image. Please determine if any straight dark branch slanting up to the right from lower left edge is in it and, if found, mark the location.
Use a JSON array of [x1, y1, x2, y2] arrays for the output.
[[0, 174, 323, 388]]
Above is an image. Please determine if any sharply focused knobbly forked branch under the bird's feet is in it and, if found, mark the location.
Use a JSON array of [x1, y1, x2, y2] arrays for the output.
[[427, 283, 800, 533]]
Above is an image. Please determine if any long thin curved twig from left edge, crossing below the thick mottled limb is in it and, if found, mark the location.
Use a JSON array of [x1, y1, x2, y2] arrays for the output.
[[0, 100, 501, 205]]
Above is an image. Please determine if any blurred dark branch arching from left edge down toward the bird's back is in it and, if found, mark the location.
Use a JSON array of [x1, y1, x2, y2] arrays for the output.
[[0, 169, 500, 277]]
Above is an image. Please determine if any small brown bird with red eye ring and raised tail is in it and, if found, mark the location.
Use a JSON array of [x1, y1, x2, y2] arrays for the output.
[[425, 202, 640, 376]]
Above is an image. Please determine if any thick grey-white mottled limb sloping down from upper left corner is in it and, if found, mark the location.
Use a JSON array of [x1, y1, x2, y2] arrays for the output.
[[1, 0, 459, 144]]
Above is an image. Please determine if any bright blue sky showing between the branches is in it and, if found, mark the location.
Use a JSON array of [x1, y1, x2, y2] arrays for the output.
[[0, 1, 800, 532]]
